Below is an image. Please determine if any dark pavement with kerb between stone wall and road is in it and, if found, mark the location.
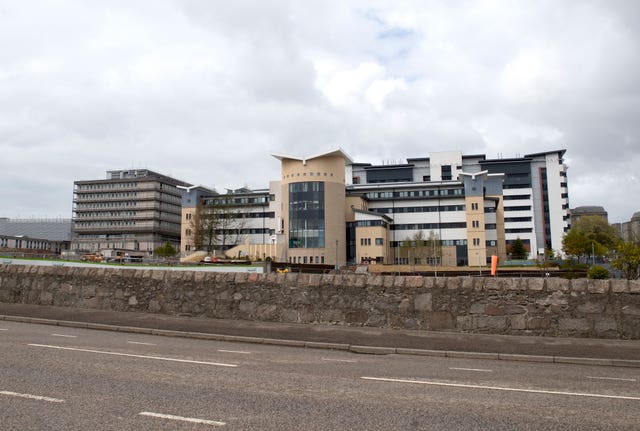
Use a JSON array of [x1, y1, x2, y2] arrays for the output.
[[0, 303, 640, 368]]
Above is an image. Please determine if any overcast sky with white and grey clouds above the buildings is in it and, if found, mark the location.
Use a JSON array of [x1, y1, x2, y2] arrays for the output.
[[0, 0, 640, 222]]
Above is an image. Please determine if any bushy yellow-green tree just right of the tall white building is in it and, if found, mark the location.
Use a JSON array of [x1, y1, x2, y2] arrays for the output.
[[562, 216, 619, 257]]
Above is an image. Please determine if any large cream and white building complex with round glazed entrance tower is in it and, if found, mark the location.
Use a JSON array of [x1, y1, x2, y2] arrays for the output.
[[182, 149, 569, 266]]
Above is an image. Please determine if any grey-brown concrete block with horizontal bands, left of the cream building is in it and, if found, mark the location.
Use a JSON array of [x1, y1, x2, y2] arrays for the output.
[[71, 169, 190, 256]]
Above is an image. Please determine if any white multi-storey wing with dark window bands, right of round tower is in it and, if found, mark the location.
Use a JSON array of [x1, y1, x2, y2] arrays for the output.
[[347, 150, 569, 264]]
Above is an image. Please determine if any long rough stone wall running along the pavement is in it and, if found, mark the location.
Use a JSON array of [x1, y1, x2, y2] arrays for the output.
[[0, 265, 640, 339]]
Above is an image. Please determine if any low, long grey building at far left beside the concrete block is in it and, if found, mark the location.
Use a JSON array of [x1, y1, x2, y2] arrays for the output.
[[0, 218, 71, 255]]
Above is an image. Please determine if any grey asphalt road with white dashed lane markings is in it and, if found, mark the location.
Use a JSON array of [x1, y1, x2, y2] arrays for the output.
[[0, 321, 640, 430]]
